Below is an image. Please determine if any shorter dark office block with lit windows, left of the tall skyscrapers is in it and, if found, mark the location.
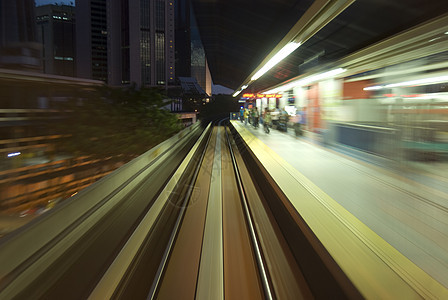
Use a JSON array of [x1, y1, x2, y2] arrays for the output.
[[36, 4, 76, 77]]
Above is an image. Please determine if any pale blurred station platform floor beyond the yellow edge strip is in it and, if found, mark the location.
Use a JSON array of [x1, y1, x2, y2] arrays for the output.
[[232, 121, 448, 289]]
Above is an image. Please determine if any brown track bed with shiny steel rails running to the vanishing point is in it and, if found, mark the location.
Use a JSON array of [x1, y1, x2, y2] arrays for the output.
[[91, 121, 359, 299]]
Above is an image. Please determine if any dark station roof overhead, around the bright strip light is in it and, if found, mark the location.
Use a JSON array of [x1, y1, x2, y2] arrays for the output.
[[192, 0, 448, 92]]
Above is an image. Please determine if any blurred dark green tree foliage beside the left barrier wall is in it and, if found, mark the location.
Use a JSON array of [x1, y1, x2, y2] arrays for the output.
[[58, 86, 181, 159]]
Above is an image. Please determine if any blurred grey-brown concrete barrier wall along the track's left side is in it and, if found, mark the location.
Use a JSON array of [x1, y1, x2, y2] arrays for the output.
[[0, 123, 202, 282]]
